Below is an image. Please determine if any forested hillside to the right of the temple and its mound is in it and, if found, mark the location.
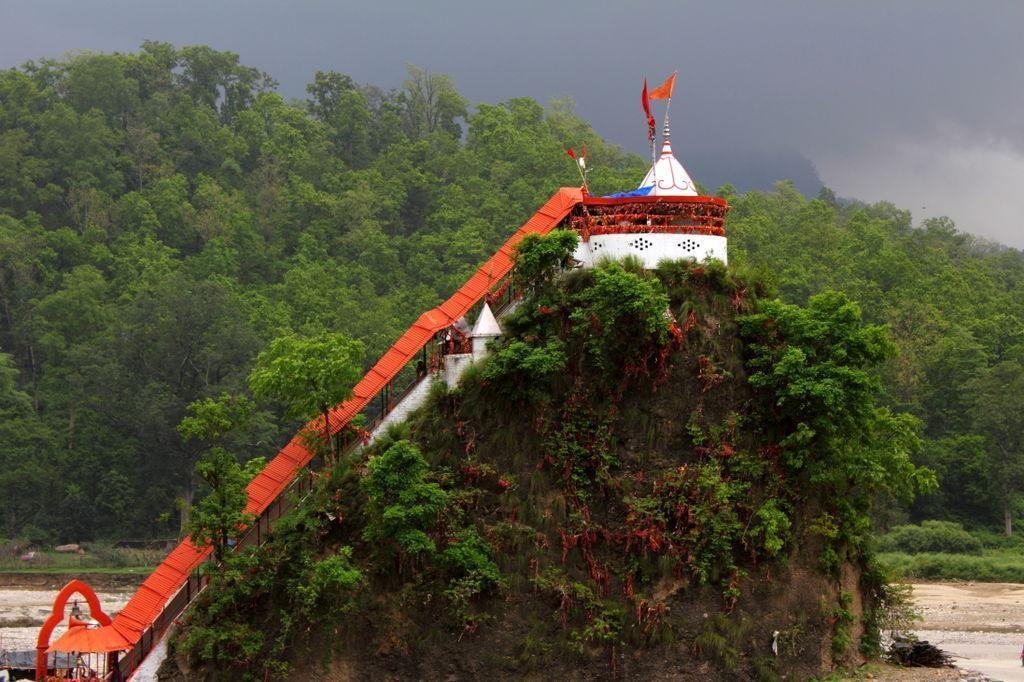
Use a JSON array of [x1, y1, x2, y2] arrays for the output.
[[724, 183, 1024, 526]]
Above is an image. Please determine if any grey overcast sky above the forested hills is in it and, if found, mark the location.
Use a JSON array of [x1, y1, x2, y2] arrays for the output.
[[6, 0, 1024, 248]]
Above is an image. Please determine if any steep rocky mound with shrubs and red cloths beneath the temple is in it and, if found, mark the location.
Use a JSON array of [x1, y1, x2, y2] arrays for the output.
[[162, 233, 931, 680]]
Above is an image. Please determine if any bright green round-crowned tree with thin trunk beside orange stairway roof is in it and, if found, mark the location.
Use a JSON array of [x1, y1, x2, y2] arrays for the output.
[[249, 334, 364, 464]]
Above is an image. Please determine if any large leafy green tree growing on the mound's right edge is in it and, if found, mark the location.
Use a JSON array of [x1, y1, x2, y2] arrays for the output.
[[738, 292, 935, 543]]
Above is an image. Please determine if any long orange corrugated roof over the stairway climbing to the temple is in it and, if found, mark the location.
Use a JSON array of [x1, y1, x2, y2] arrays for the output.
[[106, 187, 583, 644]]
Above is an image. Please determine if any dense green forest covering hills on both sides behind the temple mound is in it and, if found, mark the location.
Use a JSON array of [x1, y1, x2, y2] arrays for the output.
[[0, 42, 1024, 542]]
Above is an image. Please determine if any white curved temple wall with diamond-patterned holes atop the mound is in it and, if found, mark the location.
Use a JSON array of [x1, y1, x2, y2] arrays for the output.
[[573, 232, 729, 268]]
